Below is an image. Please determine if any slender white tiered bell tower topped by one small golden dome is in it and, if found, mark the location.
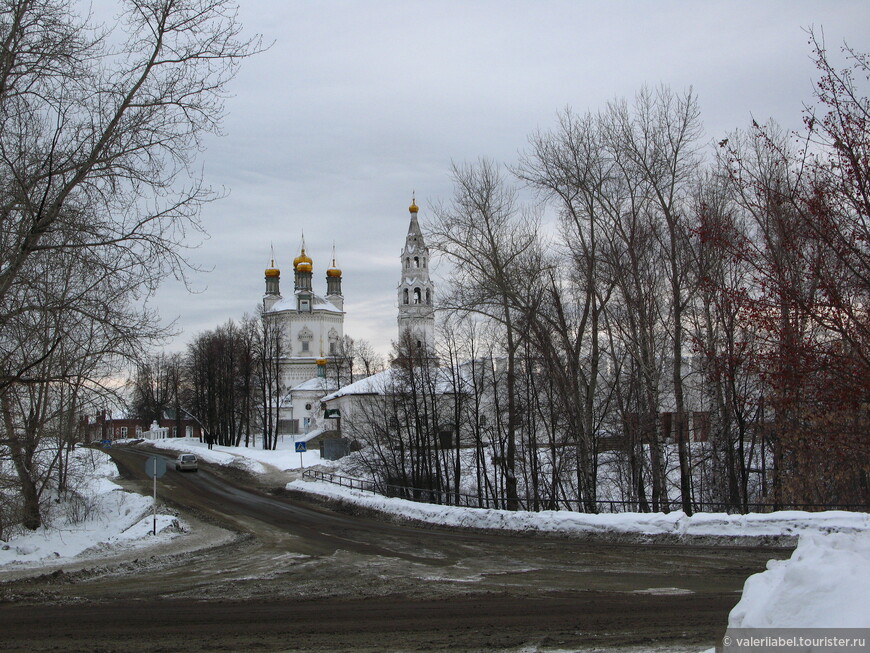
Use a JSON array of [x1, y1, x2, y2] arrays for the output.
[[398, 198, 435, 351]]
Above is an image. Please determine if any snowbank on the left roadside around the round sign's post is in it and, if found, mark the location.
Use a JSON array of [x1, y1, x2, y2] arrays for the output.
[[0, 449, 178, 570]]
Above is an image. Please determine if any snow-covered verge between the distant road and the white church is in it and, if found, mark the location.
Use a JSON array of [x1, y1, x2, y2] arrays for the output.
[[142, 435, 333, 474]]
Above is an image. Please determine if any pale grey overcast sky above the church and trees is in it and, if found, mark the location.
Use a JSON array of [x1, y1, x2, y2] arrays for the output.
[[155, 0, 870, 353]]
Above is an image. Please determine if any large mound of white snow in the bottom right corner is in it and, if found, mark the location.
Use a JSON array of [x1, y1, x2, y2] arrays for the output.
[[728, 532, 870, 628]]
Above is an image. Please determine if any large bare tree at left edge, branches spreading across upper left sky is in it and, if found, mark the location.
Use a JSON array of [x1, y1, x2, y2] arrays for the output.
[[0, 0, 259, 528]]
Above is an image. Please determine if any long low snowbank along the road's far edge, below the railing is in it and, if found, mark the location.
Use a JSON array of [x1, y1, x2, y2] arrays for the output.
[[286, 481, 870, 536]]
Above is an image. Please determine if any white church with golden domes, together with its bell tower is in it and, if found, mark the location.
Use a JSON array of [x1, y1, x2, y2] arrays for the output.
[[263, 200, 435, 446]]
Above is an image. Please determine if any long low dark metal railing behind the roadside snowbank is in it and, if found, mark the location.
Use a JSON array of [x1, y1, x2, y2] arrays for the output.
[[302, 470, 870, 514]]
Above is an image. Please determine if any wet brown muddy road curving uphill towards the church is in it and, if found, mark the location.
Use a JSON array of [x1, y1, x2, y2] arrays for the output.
[[0, 448, 790, 652]]
